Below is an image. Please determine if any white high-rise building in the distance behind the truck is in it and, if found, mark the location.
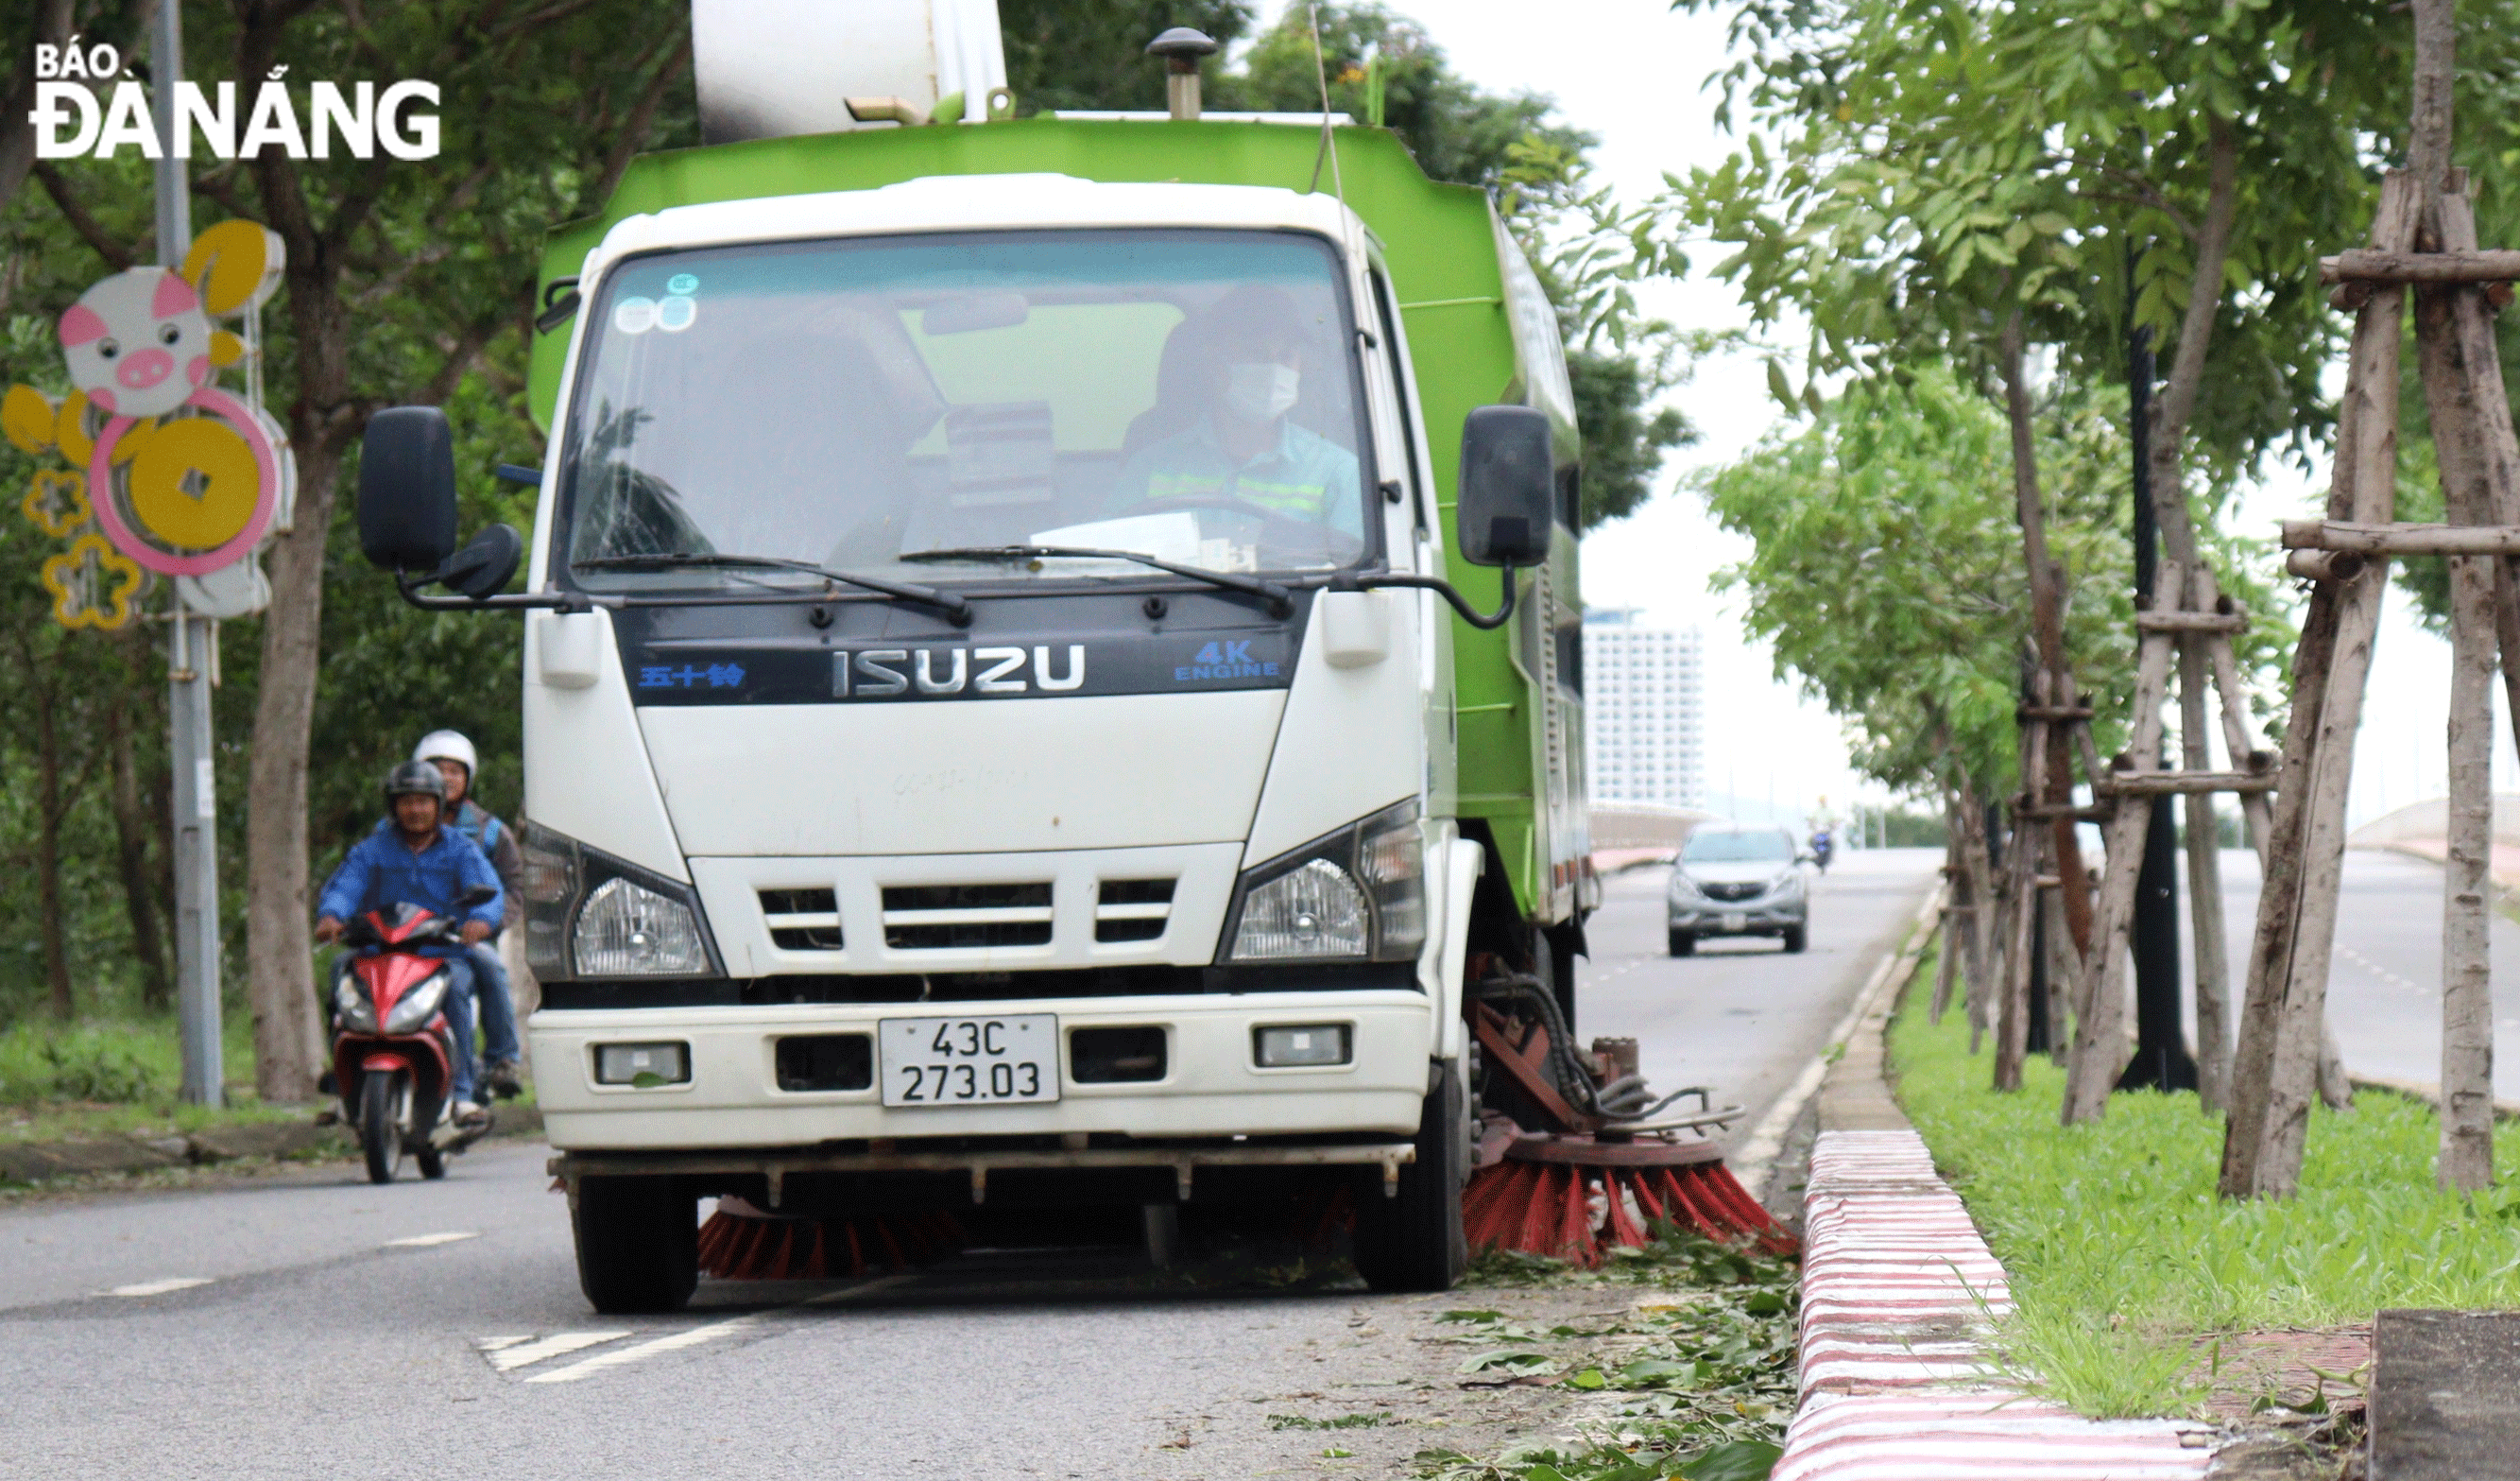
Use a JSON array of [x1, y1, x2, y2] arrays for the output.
[[1583, 607, 1706, 808]]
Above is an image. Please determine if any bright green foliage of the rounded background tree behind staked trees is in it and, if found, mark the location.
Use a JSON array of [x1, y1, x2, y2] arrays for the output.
[[1704, 363, 2290, 796]]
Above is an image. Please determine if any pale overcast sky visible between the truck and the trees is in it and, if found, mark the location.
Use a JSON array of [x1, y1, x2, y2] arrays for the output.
[[1262, 0, 2489, 821]]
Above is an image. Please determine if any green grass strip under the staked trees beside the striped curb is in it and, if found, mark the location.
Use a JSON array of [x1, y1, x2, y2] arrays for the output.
[[1890, 959, 2520, 1416]]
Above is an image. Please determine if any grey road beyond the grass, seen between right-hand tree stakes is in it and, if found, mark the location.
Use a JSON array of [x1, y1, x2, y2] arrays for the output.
[[2180, 849, 2520, 1101]]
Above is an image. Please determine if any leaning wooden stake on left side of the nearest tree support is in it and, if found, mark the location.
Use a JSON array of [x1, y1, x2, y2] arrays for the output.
[[2218, 171, 2414, 1199]]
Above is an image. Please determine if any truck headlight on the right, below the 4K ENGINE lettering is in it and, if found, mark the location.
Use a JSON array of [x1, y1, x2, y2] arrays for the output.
[[1225, 801, 1427, 962]]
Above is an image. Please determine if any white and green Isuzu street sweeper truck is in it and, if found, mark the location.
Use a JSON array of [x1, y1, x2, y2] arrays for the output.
[[360, 83, 1595, 1310]]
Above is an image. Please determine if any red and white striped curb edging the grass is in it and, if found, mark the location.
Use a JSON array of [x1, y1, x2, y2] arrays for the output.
[[1772, 1128, 2213, 1481]]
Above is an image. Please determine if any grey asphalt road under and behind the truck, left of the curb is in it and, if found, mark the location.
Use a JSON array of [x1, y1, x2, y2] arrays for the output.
[[0, 852, 1935, 1481]]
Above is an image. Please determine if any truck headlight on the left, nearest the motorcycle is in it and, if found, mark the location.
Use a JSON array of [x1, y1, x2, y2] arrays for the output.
[[517, 821, 723, 980]]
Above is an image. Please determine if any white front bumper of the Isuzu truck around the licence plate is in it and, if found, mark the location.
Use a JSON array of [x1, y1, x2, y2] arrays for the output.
[[526, 992, 1436, 1151]]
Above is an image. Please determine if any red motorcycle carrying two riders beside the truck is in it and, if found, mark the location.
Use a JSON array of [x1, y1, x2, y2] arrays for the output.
[[330, 889, 489, 1184]]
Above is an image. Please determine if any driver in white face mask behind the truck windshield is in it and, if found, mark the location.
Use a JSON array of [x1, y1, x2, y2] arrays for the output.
[[1106, 284, 1363, 539]]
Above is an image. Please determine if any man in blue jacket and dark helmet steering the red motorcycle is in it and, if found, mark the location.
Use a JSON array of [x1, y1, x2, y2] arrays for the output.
[[315, 761, 506, 1124]]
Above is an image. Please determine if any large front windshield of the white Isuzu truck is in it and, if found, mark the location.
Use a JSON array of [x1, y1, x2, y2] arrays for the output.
[[559, 232, 1368, 590]]
